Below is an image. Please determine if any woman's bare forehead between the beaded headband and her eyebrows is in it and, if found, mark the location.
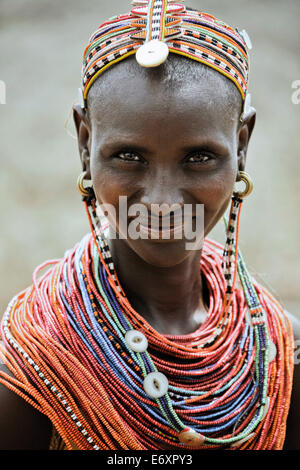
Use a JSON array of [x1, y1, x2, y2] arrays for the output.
[[88, 58, 241, 133]]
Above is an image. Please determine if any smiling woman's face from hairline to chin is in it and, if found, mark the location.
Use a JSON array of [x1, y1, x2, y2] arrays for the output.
[[75, 58, 253, 266]]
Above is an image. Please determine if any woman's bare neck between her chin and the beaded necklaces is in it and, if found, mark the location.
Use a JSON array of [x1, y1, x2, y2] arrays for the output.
[[109, 239, 208, 335]]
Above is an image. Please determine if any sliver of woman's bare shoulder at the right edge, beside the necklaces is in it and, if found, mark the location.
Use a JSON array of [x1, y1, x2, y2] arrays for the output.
[[284, 311, 300, 450]]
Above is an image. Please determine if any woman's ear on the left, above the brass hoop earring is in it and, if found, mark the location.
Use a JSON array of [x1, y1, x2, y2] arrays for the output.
[[73, 103, 91, 179]]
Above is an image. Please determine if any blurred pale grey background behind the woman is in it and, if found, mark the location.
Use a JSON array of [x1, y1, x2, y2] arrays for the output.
[[0, 0, 300, 316]]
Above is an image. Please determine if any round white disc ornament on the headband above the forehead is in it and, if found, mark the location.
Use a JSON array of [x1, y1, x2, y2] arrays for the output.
[[136, 39, 169, 67]]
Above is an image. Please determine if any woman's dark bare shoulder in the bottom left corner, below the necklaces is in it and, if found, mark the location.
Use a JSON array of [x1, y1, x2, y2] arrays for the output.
[[0, 363, 52, 450]]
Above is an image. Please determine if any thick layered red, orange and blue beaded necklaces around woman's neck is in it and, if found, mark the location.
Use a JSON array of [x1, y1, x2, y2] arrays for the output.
[[0, 196, 293, 450]]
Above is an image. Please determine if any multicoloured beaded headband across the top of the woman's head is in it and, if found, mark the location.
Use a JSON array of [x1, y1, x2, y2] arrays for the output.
[[79, 0, 252, 112]]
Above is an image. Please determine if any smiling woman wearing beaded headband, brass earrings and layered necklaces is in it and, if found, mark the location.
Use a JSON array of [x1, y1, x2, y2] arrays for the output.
[[0, 0, 300, 450]]
